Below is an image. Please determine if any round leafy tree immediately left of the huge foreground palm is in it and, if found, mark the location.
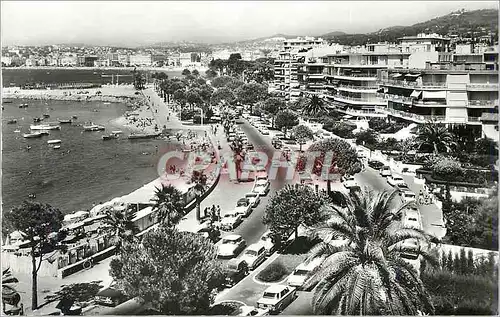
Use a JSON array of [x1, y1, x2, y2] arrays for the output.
[[263, 184, 325, 238]]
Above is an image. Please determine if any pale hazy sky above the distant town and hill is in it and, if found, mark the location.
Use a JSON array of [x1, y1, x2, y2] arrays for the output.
[[1, 1, 498, 47]]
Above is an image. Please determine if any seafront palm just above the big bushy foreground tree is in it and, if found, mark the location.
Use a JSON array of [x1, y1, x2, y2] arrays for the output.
[[152, 184, 184, 227]]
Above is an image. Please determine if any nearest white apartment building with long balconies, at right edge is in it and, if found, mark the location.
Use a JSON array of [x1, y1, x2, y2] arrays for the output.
[[377, 46, 499, 140]]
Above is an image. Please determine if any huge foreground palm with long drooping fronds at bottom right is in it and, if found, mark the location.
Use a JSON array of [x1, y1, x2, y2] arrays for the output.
[[304, 190, 435, 315]]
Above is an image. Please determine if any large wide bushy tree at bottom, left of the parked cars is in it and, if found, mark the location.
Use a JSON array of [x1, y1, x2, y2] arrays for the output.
[[110, 227, 224, 315]]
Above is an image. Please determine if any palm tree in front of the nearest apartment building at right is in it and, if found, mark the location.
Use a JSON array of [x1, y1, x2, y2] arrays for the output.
[[416, 121, 456, 154]]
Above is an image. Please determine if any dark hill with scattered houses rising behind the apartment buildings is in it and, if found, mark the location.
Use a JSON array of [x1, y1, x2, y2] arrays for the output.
[[321, 9, 498, 45]]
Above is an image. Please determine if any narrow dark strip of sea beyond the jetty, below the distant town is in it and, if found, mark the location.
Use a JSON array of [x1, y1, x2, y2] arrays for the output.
[[2, 67, 182, 87]]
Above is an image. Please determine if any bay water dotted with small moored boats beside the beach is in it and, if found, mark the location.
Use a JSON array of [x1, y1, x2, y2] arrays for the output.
[[1, 100, 182, 213]]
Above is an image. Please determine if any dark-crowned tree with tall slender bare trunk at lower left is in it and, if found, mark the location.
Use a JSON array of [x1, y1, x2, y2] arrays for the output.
[[3, 201, 64, 310]]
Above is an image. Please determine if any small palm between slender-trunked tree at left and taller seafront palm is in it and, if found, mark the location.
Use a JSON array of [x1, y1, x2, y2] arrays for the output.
[[103, 206, 139, 250]]
